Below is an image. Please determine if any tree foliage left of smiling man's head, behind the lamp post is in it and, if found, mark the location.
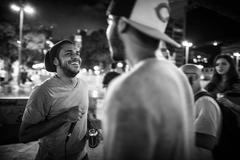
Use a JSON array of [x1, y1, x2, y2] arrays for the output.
[[0, 21, 52, 66]]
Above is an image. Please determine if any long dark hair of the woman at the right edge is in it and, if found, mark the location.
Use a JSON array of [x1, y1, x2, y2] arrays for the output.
[[211, 54, 239, 83]]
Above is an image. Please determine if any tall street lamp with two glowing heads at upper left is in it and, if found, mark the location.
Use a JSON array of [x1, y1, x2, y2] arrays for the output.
[[10, 3, 34, 85]]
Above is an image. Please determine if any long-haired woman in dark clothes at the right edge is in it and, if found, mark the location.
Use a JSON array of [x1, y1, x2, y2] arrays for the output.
[[205, 55, 240, 113]]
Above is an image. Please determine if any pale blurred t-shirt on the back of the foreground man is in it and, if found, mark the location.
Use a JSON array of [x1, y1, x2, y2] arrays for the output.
[[103, 58, 195, 160]]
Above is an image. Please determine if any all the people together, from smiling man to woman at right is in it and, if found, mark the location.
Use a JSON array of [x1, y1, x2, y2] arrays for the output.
[[19, 0, 240, 160]]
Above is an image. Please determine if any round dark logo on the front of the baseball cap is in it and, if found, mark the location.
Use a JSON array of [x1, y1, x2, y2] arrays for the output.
[[155, 3, 170, 23]]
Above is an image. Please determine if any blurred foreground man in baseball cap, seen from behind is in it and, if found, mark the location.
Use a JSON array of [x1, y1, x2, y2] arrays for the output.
[[103, 0, 195, 160]]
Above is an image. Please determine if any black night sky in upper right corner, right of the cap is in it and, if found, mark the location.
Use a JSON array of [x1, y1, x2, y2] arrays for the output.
[[186, 0, 240, 45]]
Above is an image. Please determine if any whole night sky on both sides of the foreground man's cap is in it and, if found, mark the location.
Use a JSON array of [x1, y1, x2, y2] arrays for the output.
[[0, 0, 240, 44]]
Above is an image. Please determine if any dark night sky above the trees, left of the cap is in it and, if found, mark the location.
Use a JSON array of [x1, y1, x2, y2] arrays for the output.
[[0, 0, 108, 39]]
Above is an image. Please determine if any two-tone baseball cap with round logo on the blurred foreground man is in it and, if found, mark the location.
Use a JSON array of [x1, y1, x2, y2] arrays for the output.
[[107, 0, 180, 48]]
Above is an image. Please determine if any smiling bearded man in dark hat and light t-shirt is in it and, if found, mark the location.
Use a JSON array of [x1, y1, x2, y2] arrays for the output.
[[20, 40, 88, 160]]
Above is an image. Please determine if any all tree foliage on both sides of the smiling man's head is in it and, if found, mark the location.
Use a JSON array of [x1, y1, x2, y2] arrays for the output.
[[0, 19, 112, 69]]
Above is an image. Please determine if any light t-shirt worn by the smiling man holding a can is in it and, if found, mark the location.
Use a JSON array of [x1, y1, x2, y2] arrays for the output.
[[22, 76, 88, 160]]
